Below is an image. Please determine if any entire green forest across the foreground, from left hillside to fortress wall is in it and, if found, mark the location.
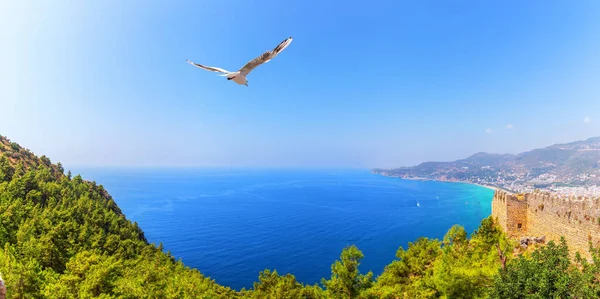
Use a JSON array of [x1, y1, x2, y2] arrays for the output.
[[0, 136, 600, 298]]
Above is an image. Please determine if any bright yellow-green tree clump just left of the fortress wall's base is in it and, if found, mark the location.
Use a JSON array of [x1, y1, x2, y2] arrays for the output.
[[365, 217, 507, 298]]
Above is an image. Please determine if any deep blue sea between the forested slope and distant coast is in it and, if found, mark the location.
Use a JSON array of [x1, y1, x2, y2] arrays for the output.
[[74, 169, 493, 289]]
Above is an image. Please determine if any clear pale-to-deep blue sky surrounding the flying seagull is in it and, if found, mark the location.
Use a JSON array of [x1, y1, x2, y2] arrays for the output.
[[0, 0, 600, 167]]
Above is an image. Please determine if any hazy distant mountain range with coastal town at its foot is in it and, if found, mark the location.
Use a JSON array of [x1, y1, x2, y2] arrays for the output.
[[373, 137, 600, 191]]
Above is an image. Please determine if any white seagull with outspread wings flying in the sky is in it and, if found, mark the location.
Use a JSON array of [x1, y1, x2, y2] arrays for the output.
[[186, 36, 292, 86]]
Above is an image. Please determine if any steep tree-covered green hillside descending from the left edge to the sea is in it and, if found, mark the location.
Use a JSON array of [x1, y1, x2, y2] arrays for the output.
[[0, 136, 237, 298]]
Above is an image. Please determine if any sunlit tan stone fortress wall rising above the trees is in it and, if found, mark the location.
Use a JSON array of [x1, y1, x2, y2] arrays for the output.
[[492, 191, 600, 257]]
